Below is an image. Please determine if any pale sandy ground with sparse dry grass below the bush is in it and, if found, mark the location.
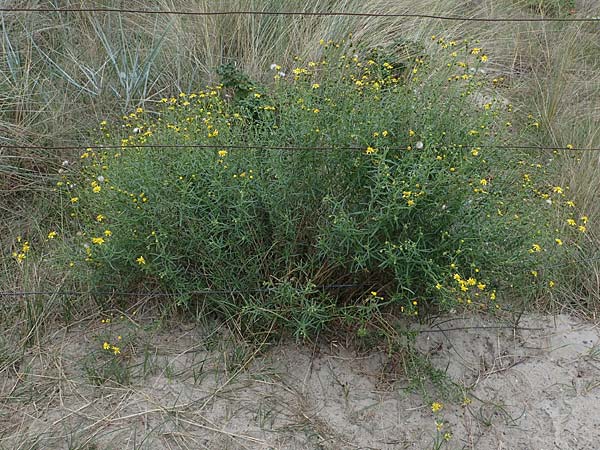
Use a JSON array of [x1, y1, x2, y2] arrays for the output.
[[0, 315, 600, 450]]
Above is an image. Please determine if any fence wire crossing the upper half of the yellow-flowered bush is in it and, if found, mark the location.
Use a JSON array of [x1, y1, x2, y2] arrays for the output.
[[0, 141, 600, 153]]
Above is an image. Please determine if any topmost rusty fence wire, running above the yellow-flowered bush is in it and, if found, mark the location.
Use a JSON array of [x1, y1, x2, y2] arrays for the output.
[[0, 7, 600, 22]]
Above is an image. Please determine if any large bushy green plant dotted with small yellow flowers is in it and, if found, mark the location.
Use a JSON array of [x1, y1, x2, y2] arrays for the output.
[[47, 37, 587, 337]]
